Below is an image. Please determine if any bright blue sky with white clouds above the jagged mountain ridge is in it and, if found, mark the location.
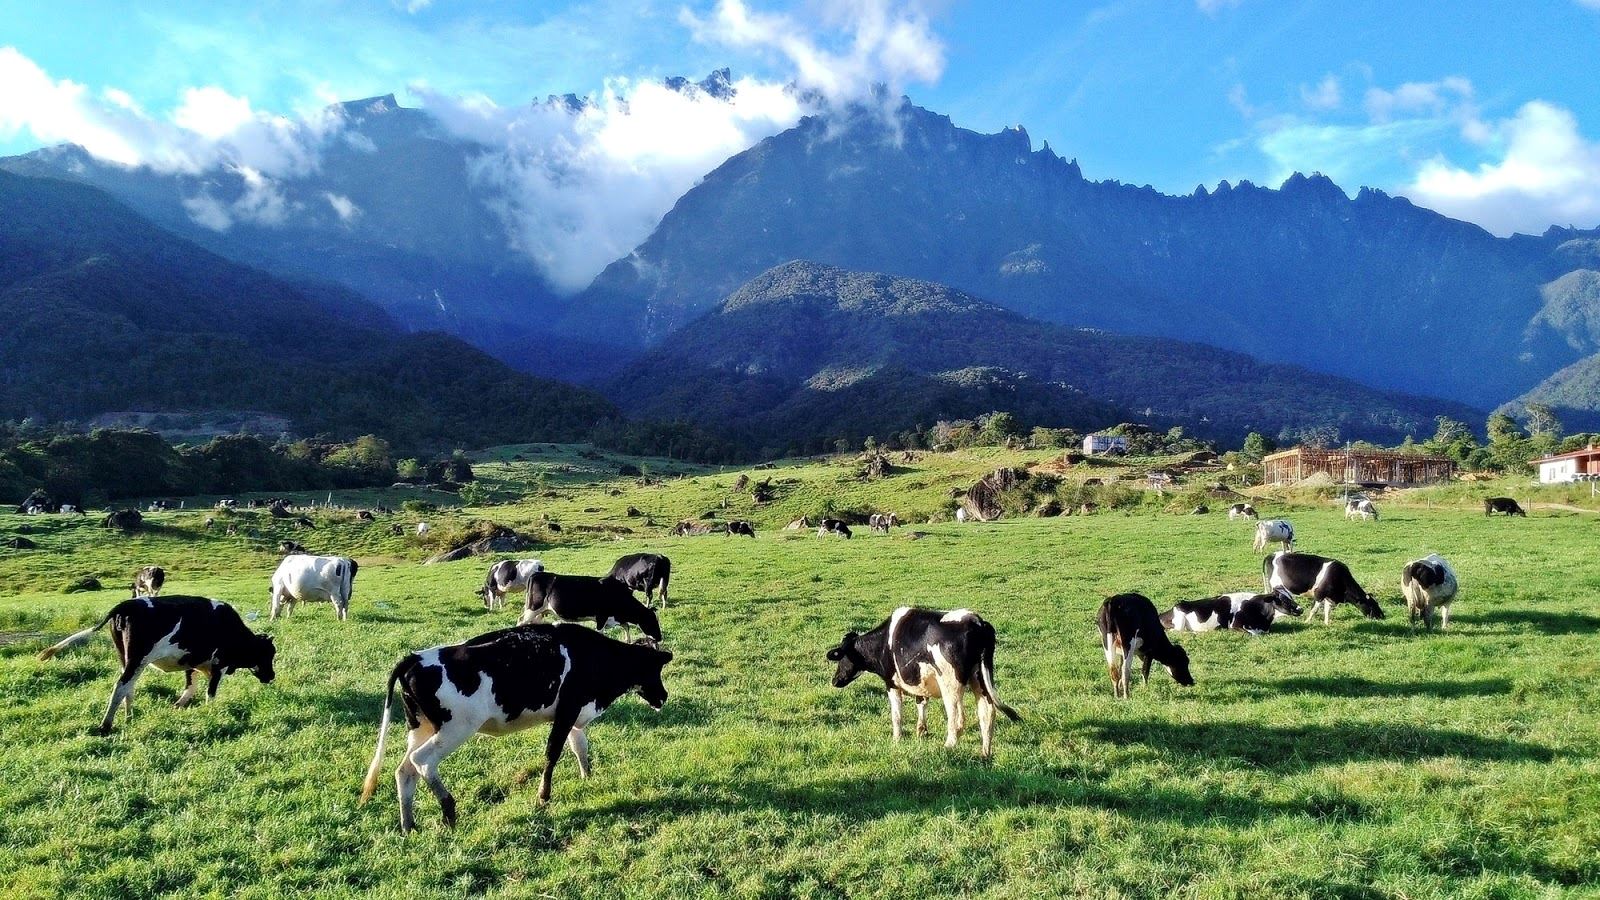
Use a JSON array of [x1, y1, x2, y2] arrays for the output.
[[0, 0, 1600, 234]]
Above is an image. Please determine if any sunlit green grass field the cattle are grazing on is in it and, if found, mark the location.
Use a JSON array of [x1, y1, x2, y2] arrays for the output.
[[0, 448, 1600, 898]]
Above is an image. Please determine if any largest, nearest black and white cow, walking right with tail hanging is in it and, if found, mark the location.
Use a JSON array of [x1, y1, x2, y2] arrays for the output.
[[362, 625, 672, 831]]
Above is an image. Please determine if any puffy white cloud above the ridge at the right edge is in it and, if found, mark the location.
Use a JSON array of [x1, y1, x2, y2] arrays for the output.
[[1406, 101, 1600, 234]]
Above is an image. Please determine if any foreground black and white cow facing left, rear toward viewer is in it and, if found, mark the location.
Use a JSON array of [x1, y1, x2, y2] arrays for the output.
[[827, 607, 1021, 757]]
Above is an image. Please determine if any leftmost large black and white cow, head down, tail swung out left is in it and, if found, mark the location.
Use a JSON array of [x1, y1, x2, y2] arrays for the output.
[[38, 597, 277, 735]]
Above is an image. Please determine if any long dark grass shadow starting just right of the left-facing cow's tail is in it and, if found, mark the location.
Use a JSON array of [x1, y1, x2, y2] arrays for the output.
[[1080, 719, 1555, 772]]
